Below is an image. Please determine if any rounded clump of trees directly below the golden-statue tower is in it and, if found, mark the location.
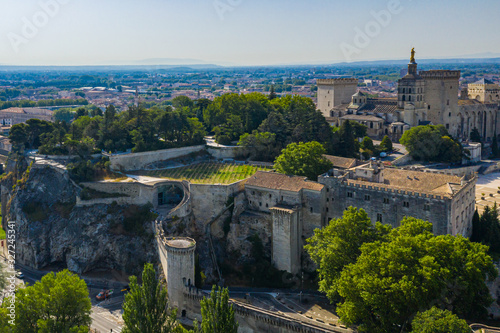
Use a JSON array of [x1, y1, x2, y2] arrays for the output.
[[399, 125, 466, 163]]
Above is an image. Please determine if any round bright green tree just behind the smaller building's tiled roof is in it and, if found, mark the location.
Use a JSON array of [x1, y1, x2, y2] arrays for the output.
[[274, 141, 333, 180]]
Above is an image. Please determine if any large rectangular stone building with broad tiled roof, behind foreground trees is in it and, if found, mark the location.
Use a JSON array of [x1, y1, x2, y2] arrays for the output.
[[319, 163, 476, 237]]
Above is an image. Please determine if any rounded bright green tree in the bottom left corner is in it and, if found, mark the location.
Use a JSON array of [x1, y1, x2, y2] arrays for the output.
[[14, 270, 91, 333]]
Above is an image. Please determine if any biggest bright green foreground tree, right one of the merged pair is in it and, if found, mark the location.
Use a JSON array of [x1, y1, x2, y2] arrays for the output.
[[336, 218, 497, 333]]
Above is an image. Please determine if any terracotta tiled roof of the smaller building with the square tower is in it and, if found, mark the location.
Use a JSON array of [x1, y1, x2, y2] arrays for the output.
[[245, 171, 324, 192]]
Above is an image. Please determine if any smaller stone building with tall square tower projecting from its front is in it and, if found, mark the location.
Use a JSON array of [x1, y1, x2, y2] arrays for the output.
[[245, 171, 326, 274]]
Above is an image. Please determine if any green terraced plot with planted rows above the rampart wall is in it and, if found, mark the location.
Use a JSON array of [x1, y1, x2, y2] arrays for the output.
[[141, 163, 270, 184]]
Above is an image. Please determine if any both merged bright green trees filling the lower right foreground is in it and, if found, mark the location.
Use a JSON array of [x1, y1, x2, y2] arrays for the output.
[[306, 209, 497, 332]]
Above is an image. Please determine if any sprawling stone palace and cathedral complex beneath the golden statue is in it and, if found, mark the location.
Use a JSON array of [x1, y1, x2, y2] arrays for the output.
[[318, 51, 500, 141]]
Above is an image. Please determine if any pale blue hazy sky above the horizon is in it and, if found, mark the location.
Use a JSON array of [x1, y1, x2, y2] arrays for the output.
[[0, 0, 500, 66]]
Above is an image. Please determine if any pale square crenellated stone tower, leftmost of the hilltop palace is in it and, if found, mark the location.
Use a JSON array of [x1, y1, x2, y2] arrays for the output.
[[316, 78, 358, 117]]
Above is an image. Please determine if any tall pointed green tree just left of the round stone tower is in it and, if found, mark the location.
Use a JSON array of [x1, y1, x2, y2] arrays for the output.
[[122, 264, 182, 333]]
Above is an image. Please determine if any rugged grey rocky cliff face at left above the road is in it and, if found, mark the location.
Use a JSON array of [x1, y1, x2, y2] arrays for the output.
[[2, 165, 158, 274]]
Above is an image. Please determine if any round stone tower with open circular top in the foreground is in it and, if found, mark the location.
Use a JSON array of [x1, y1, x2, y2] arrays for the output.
[[163, 237, 196, 311]]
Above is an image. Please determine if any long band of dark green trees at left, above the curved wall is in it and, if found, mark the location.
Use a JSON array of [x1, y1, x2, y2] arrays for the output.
[[9, 106, 206, 154]]
